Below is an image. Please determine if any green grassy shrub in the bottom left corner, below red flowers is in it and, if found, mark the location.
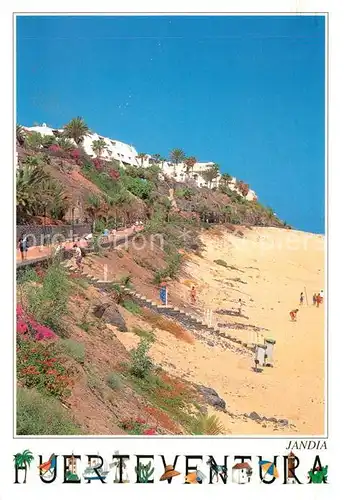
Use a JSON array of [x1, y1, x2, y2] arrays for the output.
[[17, 387, 83, 436]]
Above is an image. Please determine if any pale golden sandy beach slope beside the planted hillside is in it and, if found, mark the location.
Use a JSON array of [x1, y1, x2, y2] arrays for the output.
[[113, 228, 326, 435]]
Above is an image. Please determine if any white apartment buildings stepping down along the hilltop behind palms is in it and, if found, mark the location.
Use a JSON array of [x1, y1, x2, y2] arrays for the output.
[[23, 123, 256, 201]]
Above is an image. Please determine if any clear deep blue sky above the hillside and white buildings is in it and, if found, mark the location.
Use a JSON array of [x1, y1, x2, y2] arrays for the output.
[[17, 16, 325, 233]]
